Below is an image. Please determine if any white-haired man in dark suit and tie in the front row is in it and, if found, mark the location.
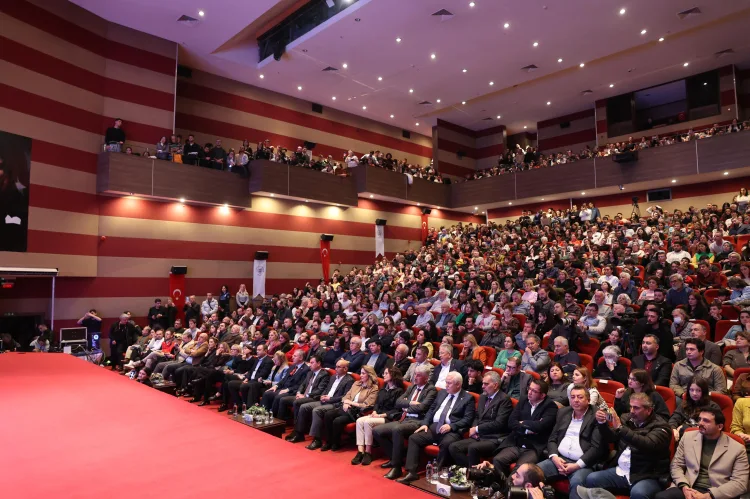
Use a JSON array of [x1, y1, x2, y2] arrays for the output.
[[398, 371, 475, 483]]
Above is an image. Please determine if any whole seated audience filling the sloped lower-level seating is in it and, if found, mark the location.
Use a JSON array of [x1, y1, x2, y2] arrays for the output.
[[22, 188, 750, 499]]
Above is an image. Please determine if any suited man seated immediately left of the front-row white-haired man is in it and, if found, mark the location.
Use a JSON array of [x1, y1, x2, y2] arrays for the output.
[[373, 366, 437, 480]]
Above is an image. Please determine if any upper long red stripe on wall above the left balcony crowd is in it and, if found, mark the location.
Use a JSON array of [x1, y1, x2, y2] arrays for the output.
[[177, 80, 432, 158]]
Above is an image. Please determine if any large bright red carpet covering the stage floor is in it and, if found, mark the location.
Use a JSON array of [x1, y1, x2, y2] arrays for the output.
[[0, 353, 429, 499]]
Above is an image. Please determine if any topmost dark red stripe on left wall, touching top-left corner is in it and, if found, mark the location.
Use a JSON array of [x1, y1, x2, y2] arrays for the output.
[[0, 0, 175, 76]]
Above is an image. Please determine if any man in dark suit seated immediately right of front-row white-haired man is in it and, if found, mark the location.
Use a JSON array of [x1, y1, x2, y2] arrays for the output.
[[448, 371, 513, 468]]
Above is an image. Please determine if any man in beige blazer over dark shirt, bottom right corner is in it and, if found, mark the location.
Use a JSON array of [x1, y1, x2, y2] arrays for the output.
[[656, 407, 748, 499]]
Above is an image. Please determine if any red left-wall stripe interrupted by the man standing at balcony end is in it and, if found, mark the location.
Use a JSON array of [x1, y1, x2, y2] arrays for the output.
[[0, 83, 172, 144]]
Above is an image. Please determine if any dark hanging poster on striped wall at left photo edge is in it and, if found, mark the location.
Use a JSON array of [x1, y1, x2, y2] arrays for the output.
[[0, 131, 31, 251]]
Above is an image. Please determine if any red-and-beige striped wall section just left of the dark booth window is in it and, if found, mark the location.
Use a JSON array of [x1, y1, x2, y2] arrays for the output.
[[536, 109, 596, 153]]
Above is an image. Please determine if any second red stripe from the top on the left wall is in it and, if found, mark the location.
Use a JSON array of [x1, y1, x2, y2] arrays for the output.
[[0, 36, 174, 112]]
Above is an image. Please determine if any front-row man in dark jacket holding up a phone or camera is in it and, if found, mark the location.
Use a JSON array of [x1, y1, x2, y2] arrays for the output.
[[586, 393, 672, 499]]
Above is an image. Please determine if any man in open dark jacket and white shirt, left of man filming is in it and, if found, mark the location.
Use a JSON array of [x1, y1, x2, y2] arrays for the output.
[[538, 386, 607, 499]]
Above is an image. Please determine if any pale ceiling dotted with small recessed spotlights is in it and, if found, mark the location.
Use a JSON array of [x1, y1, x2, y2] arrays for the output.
[[72, 0, 750, 135]]
